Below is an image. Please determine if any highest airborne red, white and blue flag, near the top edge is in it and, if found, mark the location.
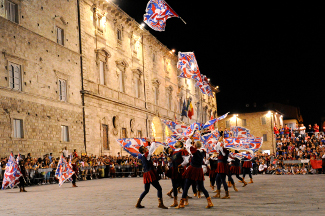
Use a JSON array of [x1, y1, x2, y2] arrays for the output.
[[143, 0, 179, 31]]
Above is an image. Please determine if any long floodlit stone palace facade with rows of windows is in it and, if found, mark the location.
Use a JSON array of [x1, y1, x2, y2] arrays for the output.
[[0, 0, 218, 157]]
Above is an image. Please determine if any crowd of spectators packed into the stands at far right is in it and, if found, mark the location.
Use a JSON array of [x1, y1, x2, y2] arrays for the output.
[[254, 124, 325, 175]]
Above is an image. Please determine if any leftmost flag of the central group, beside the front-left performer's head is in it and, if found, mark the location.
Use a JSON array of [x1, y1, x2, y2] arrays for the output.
[[117, 138, 165, 159]]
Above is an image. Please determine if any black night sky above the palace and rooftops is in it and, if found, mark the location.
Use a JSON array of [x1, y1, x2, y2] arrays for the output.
[[113, 0, 325, 125]]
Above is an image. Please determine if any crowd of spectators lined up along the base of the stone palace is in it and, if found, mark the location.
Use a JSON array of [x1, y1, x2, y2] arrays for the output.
[[0, 148, 142, 185]]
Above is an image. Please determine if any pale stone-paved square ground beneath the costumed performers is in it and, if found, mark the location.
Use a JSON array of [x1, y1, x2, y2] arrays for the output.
[[0, 175, 325, 216]]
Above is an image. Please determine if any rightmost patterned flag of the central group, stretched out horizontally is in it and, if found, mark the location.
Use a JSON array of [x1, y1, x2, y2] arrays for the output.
[[224, 137, 263, 152]]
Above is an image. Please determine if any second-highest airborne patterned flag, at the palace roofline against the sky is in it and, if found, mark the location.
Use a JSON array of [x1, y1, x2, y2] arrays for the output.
[[177, 52, 202, 83]]
